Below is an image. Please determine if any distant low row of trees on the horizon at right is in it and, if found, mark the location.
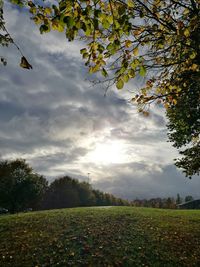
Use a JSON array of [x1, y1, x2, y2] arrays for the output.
[[131, 194, 194, 209]]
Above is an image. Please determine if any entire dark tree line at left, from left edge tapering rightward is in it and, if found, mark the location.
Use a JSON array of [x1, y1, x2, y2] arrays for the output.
[[0, 159, 129, 213]]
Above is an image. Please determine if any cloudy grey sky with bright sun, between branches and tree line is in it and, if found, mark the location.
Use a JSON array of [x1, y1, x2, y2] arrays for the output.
[[0, 3, 200, 200]]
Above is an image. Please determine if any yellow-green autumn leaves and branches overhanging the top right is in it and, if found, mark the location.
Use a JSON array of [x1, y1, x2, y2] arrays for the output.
[[12, 0, 200, 108]]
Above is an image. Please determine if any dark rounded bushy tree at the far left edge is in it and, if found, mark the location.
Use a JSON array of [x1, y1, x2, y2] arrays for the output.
[[0, 159, 47, 213]]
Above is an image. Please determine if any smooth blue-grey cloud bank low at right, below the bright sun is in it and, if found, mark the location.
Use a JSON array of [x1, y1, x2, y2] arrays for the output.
[[94, 162, 200, 200]]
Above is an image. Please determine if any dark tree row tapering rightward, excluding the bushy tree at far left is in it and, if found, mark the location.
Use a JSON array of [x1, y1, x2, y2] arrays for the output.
[[39, 176, 129, 209]]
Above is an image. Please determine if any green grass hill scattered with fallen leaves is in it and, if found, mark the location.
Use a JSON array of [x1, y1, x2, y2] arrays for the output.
[[0, 207, 200, 267]]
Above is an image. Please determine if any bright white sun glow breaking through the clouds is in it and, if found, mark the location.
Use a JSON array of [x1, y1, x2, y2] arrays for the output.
[[86, 141, 130, 165]]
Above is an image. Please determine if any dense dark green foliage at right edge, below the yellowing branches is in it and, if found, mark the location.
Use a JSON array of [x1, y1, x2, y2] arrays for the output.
[[166, 71, 200, 178]]
